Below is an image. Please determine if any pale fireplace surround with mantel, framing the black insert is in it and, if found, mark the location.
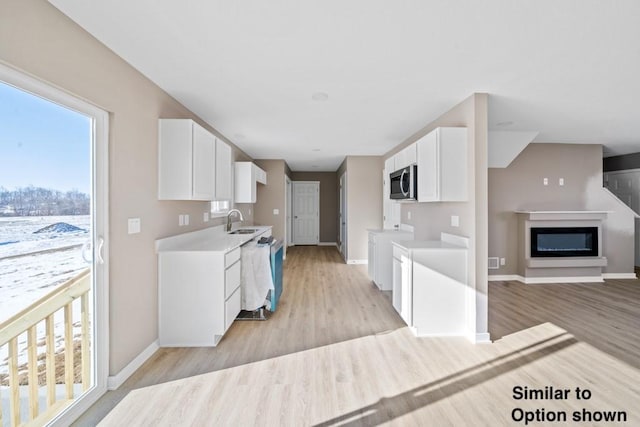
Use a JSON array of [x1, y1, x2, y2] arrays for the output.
[[516, 211, 608, 283]]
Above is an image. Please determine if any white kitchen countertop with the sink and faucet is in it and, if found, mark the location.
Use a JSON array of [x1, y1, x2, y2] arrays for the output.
[[156, 225, 272, 253]]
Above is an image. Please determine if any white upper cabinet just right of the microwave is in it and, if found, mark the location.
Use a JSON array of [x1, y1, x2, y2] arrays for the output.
[[417, 127, 468, 202]]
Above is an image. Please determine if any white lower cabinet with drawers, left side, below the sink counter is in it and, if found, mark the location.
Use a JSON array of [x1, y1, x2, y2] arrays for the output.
[[158, 248, 241, 347]]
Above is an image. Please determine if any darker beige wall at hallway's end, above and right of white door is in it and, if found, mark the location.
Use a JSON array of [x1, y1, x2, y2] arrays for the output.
[[291, 172, 339, 243]]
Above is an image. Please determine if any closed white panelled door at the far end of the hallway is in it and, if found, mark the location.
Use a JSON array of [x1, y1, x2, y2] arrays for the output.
[[292, 181, 320, 245]]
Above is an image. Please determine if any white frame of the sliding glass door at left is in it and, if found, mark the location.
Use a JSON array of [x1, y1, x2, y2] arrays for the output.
[[0, 62, 109, 426]]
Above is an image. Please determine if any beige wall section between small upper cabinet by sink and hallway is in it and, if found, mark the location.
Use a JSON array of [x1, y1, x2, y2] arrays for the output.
[[253, 160, 289, 239]]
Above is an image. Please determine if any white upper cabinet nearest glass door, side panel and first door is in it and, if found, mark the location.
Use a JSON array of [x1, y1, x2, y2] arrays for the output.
[[158, 119, 216, 200]]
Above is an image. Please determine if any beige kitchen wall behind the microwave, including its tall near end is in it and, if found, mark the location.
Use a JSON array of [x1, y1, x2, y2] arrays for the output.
[[384, 93, 488, 342]]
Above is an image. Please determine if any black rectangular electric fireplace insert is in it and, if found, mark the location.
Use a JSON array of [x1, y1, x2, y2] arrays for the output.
[[531, 227, 598, 258]]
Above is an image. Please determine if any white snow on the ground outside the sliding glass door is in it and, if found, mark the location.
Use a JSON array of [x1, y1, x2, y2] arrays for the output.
[[0, 215, 91, 373]]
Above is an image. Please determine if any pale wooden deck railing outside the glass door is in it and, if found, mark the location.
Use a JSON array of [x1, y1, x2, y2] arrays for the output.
[[0, 269, 91, 426]]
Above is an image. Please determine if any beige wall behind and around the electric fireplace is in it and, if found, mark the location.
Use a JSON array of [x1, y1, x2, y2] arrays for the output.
[[489, 144, 634, 275]]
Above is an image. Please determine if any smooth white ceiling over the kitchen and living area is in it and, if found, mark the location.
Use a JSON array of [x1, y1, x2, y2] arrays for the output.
[[50, 0, 640, 171]]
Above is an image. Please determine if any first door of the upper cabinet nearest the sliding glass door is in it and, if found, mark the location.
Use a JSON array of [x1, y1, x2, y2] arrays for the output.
[[193, 123, 216, 200]]
